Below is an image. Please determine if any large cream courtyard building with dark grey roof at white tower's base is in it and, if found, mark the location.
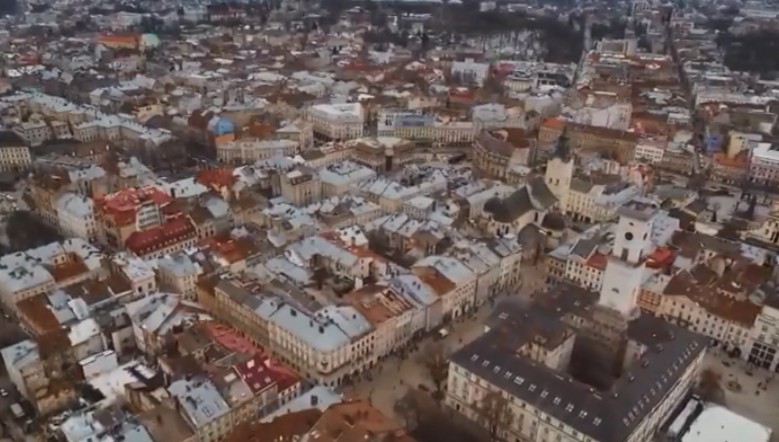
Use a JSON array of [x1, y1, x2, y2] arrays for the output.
[[446, 285, 706, 442]]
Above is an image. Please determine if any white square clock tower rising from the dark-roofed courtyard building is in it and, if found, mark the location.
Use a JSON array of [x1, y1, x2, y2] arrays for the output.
[[599, 201, 656, 318]]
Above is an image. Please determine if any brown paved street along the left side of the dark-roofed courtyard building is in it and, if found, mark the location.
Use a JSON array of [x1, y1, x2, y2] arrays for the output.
[[353, 266, 544, 422]]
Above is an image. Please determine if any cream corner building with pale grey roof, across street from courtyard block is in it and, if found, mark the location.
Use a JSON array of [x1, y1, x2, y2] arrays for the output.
[[198, 279, 380, 386]]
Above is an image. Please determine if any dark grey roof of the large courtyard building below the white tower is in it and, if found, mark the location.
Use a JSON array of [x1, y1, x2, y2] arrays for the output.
[[451, 284, 706, 442]]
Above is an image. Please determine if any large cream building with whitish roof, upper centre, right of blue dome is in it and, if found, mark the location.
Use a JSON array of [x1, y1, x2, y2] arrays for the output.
[[305, 103, 365, 141]]
